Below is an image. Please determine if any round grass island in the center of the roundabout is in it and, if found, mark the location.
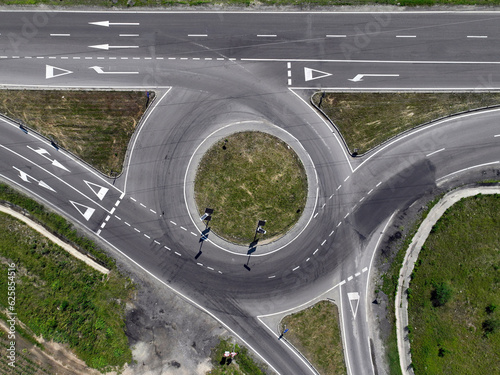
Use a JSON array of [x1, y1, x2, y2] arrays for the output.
[[195, 132, 307, 245]]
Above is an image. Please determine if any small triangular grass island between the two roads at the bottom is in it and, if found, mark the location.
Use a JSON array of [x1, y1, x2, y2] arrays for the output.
[[281, 301, 347, 375]]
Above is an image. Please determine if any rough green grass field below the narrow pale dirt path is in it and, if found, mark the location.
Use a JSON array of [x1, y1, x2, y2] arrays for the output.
[[0, 213, 133, 371]]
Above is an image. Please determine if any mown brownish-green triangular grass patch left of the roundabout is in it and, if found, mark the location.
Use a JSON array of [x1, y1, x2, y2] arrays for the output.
[[0, 90, 147, 176]]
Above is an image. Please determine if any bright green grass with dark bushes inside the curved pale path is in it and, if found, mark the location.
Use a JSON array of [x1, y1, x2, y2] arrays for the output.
[[409, 195, 500, 375]]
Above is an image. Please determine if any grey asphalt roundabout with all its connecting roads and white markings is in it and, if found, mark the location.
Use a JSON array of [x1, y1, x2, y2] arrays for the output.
[[0, 11, 500, 375]]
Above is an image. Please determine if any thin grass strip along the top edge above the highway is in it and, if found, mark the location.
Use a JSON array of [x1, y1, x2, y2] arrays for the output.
[[0, 0, 500, 8]]
